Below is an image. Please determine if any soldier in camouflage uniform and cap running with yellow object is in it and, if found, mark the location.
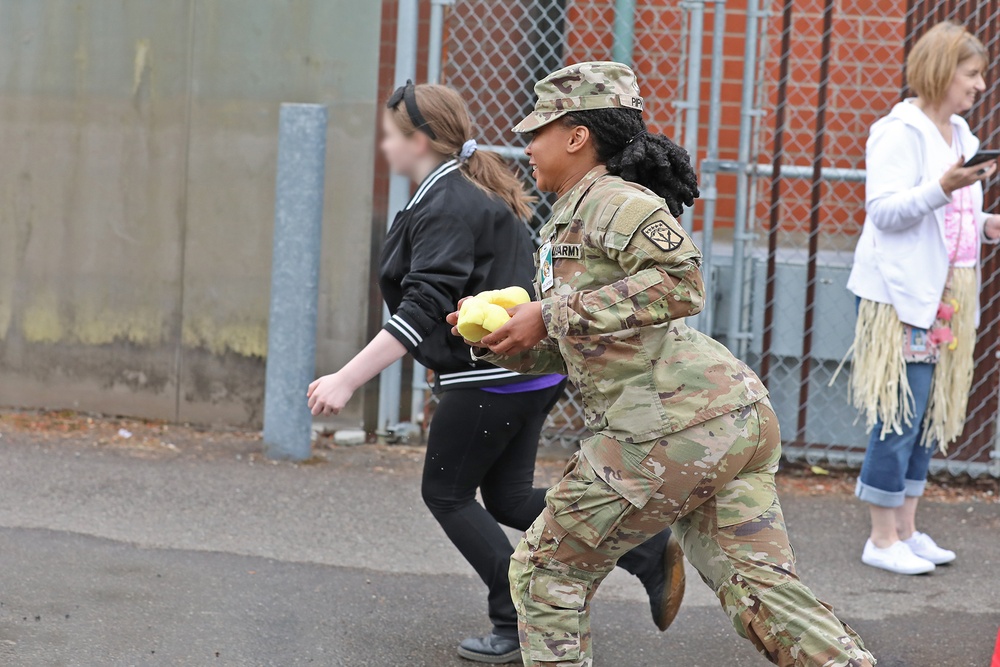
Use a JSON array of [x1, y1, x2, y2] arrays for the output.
[[450, 63, 875, 667]]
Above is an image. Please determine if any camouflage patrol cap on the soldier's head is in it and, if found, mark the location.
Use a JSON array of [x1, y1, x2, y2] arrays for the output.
[[514, 62, 642, 132]]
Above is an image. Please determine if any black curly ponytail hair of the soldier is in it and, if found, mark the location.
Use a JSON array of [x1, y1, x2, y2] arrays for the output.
[[562, 107, 700, 217]]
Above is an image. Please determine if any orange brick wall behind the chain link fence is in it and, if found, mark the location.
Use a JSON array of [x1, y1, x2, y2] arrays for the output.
[[366, 0, 1000, 457]]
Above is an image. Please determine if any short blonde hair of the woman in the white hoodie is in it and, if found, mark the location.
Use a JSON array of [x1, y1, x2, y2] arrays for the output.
[[906, 21, 989, 103]]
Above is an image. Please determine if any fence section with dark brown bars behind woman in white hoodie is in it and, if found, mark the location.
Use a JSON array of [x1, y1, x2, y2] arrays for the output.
[[747, 0, 1000, 474]]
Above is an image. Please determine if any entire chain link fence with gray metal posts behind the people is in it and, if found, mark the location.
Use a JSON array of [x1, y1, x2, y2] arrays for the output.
[[408, 0, 1000, 475]]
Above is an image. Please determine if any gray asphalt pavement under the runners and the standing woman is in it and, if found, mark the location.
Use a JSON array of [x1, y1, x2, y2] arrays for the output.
[[0, 423, 1000, 667]]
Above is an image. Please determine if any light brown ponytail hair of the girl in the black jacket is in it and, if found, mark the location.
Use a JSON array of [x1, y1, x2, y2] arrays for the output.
[[389, 83, 535, 220]]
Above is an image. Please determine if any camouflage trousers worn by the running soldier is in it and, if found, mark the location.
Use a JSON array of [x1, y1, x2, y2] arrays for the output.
[[510, 401, 875, 667]]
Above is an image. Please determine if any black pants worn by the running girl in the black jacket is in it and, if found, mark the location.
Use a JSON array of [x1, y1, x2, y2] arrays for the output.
[[421, 385, 665, 637]]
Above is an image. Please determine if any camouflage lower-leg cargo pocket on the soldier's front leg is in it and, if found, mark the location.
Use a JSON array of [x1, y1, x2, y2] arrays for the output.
[[526, 568, 588, 662]]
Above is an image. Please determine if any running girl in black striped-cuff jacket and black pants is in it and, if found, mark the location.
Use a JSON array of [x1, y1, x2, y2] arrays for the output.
[[308, 83, 683, 663]]
